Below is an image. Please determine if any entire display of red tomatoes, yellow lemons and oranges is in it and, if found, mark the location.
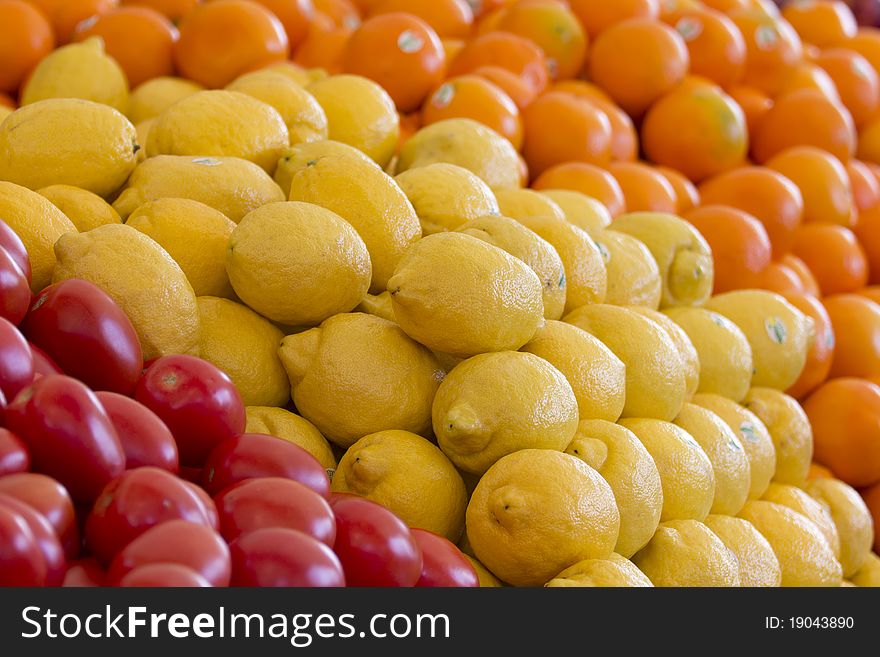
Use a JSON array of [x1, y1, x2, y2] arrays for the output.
[[0, 0, 880, 587]]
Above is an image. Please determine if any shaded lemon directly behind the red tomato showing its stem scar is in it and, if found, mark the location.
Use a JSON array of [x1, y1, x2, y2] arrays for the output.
[[197, 297, 290, 406]]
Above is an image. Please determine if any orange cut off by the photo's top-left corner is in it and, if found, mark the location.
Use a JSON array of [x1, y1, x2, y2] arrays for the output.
[[0, 0, 55, 94]]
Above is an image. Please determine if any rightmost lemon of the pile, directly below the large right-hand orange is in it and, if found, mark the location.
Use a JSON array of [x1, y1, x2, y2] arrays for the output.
[[806, 479, 875, 578]]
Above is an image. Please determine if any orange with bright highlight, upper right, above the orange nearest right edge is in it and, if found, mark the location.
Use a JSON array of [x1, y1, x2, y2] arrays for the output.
[[767, 146, 853, 226]]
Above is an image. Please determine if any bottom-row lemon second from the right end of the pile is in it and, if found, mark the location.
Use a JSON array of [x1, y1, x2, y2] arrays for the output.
[[739, 500, 843, 586]]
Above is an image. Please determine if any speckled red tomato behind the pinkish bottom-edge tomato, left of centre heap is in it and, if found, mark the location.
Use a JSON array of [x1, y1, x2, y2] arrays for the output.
[[85, 467, 213, 564]]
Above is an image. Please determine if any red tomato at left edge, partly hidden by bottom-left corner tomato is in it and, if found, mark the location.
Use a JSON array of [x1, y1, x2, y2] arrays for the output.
[[0, 472, 79, 559]]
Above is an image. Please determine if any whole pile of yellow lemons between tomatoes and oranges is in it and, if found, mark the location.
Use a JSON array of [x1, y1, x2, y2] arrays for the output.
[[0, 41, 880, 586]]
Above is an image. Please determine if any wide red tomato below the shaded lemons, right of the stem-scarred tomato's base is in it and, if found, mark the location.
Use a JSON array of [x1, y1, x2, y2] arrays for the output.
[[202, 433, 330, 497]]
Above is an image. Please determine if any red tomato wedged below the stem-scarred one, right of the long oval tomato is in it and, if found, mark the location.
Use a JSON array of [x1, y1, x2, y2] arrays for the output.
[[95, 391, 180, 474]]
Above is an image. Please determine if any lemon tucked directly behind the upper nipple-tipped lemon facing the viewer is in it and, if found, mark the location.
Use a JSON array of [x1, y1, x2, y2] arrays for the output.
[[520, 320, 627, 420]]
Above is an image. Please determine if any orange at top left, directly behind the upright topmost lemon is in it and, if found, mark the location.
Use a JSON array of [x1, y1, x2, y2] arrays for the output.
[[73, 7, 180, 87]]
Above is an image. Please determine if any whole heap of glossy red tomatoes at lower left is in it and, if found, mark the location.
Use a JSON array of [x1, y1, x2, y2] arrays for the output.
[[0, 221, 478, 586]]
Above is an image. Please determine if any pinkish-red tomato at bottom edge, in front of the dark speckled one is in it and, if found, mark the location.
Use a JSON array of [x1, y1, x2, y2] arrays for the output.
[[107, 520, 231, 586]]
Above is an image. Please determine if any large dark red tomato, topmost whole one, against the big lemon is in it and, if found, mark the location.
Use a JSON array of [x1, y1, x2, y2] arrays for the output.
[[21, 278, 144, 395]]
